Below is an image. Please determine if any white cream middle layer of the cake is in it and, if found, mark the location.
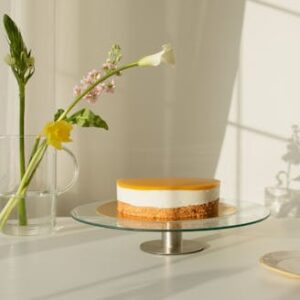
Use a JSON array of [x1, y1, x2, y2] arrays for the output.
[[117, 186, 220, 208]]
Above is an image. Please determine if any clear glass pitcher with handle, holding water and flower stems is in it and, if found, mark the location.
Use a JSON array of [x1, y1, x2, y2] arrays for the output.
[[0, 135, 79, 235]]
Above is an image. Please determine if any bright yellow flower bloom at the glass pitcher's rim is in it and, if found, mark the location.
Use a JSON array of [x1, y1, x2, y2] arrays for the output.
[[42, 120, 73, 150]]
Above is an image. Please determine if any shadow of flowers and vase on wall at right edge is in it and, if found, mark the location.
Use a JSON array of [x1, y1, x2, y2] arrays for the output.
[[265, 125, 300, 218]]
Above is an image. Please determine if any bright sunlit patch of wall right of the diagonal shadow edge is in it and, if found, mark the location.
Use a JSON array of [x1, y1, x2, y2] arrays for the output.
[[216, 0, 300, 203]]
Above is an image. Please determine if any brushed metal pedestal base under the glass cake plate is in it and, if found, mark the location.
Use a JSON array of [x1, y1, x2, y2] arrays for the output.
[[140, 231, 205, 255]]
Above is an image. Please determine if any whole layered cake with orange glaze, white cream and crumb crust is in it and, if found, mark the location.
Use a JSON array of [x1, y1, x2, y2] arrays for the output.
[[117, 178, 220, 221]]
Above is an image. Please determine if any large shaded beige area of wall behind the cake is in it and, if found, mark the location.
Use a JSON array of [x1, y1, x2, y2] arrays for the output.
[[57, 0, 245, 213]]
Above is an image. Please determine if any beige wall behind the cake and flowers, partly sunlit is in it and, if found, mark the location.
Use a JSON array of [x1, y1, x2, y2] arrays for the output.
[[7, 0, 300, 213]]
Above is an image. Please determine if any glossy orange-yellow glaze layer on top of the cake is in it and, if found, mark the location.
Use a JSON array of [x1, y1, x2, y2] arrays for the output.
[[117, 178, 220, 190]]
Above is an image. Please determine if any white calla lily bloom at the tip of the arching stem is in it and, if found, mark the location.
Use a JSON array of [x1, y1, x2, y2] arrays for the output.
[[138, 44, 175, 67]]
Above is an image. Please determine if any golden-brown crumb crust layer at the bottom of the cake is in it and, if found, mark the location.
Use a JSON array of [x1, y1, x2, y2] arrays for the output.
[[117, 199, 219, 221]]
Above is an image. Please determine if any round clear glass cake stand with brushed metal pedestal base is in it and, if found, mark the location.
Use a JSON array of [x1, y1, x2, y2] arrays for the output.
[[71, 200, 270, 255]]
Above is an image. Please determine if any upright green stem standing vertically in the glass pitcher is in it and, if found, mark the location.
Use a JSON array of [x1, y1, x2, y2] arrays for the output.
[[18, 80, 27, 226]]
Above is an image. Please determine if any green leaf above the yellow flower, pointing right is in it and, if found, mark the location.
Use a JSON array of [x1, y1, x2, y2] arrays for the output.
[[68, 108, 108, 130]]
